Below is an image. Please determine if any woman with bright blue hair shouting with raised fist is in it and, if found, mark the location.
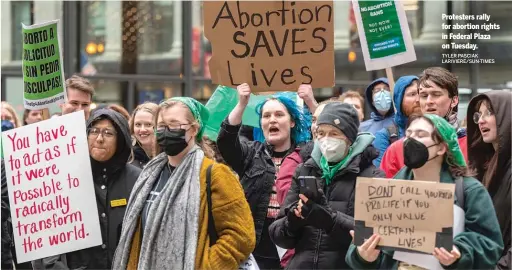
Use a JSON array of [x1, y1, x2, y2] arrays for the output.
[[217, 84, 312, 269]]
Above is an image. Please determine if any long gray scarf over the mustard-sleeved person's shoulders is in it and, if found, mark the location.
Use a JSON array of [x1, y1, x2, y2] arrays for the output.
[[112, 146, 204, 270]]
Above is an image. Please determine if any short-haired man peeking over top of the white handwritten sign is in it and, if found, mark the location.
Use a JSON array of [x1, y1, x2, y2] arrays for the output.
[[59, 75, 94, 120]]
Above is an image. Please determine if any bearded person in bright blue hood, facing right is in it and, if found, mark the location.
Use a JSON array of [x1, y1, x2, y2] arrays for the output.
[[373, 75, 421, 167]]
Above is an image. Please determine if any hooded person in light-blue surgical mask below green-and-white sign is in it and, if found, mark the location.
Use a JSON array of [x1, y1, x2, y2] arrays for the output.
[[359, 78, 395, 135]]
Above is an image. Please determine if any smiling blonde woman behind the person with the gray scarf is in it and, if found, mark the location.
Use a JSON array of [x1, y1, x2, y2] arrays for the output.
[[129, 102, 159, 169]]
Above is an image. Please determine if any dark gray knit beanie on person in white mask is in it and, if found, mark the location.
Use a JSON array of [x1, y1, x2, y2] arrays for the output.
[[316, 102, 359, 142]]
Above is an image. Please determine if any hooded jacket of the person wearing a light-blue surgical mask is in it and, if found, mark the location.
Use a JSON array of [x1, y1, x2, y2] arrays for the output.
[[359, 78, 395, 134]]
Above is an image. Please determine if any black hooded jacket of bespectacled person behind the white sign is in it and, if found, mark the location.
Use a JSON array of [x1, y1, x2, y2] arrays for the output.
[[33, 109, 141, 269]]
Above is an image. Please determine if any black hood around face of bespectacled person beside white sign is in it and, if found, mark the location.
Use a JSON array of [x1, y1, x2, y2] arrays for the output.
[[87, 109, 131, 173]]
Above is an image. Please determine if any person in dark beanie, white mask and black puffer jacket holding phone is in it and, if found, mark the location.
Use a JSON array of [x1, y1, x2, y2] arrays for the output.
[[269, 102, 384, 269]]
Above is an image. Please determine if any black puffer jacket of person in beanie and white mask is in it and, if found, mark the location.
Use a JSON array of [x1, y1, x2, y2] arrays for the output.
[[269, 135, 385, 269]]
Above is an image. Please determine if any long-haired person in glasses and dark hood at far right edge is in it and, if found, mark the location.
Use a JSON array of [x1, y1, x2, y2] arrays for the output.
[[467, 90, 512, 269]]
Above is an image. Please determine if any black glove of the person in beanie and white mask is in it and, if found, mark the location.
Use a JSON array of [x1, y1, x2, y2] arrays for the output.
[[301, 189, 337, 233]]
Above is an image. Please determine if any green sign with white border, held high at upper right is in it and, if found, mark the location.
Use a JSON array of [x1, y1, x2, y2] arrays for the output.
[[352, 0, 416, 71]]
